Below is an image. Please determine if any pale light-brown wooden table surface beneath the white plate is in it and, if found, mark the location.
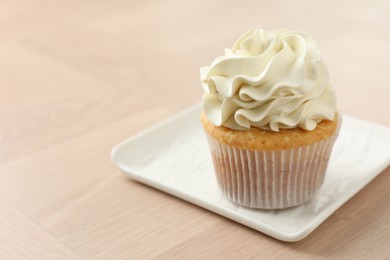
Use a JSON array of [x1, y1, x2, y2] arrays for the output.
[[0, 0, 390, 259]]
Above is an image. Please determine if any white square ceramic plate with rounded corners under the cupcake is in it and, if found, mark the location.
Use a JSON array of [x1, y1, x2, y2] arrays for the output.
[[112, 105, 390, 242]]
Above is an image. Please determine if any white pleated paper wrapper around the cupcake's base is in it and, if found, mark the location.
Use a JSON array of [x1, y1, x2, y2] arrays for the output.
[[206, 126, 338, 209]]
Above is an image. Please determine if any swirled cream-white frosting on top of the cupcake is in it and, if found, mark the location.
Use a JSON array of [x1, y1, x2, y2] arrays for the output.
[[200, 28, 336, 131]]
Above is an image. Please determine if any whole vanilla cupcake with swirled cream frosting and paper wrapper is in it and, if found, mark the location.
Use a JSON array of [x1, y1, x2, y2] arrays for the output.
[[200, 28, 340, 209]]
